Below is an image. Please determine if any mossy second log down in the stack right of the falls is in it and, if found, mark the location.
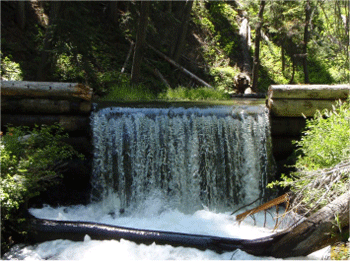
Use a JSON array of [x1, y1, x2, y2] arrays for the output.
[[267, 99, 336, 117]]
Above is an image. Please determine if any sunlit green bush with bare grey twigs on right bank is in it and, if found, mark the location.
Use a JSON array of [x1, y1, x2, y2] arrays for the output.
[[268, 100, 350, 213]]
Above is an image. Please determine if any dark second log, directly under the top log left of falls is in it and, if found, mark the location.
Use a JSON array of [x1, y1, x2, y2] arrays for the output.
[[1, 97, 91, 114]]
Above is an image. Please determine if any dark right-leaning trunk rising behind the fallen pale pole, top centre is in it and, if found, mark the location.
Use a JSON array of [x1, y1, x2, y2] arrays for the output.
[[173, 0, 194, 62]]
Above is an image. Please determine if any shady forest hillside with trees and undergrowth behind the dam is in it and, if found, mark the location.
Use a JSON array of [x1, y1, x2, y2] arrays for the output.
[[1, 0, 350, 100]]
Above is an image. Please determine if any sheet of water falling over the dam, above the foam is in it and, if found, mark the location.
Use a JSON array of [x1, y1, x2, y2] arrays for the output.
[[92, 106, 272, 212]]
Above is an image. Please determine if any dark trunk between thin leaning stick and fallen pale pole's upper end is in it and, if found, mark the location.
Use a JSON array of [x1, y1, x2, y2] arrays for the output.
[[131, 1, 150, 84]]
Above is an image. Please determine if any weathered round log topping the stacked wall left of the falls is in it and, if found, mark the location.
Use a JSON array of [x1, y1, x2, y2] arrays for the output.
[[1, 81, 92, 101]]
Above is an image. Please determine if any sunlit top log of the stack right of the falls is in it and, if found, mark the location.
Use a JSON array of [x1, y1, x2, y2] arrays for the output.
[[268, 84, 350, 100]]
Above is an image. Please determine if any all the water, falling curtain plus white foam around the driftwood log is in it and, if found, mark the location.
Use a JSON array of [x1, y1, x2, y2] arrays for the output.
[[3, 106, 329, 260]]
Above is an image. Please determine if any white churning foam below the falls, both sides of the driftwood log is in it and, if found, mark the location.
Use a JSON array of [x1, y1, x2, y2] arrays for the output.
[[4, 198, 325, 260]]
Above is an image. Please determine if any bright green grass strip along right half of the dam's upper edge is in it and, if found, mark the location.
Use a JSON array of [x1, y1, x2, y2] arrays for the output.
[[159, 87, 230, 101]]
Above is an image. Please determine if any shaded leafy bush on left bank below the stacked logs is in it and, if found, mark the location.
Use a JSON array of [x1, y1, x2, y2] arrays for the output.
[[0, 125, 82, 252]]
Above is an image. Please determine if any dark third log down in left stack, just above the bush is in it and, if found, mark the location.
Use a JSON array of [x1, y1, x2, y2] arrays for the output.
[[1, 114, 90, 134]]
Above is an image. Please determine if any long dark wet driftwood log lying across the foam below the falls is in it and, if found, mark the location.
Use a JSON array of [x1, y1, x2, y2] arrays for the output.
[[28, 192, 350, 258]]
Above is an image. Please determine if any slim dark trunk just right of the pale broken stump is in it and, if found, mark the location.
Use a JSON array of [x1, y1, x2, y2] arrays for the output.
[[252, 0, 265, 92]]
